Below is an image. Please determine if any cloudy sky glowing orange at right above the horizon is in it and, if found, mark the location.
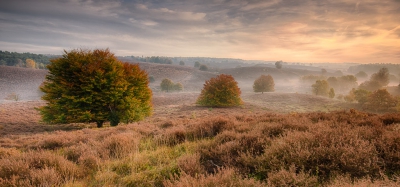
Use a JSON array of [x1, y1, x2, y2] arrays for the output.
[[0, 0, 400, 63]]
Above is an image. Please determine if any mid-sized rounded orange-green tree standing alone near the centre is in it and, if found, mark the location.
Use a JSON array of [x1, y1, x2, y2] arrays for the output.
[[196, 74, 243, 107]]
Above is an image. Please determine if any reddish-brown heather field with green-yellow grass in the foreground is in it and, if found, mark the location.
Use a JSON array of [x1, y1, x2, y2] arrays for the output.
[[0, 65, 400, 187]]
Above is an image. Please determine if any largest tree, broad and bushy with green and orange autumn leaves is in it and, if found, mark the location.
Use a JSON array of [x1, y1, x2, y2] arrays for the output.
[[39, 49, 152, 127]]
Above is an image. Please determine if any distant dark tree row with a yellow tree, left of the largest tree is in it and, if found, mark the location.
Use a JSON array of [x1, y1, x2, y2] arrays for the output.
[[0, 50, 51, 69]]
